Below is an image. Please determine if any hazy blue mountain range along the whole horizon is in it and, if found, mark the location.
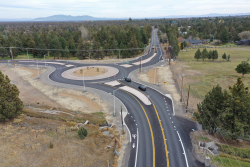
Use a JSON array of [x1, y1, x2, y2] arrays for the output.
[[0, 13, 250, 22]]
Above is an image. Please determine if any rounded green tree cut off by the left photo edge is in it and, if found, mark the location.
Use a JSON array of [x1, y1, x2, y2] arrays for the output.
[[0, 71, 23, 120]]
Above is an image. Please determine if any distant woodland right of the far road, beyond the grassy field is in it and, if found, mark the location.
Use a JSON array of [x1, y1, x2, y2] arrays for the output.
[[159, 17, 250, 43]]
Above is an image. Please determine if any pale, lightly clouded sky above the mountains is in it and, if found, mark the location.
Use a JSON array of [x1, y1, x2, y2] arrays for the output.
[[0, 0, 250, 19]]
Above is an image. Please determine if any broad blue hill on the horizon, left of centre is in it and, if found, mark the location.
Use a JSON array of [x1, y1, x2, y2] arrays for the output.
[[32, 15, 119, 21]]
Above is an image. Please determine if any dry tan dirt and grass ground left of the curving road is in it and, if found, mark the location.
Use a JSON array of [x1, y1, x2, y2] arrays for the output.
[[0, 65, 126, 167]]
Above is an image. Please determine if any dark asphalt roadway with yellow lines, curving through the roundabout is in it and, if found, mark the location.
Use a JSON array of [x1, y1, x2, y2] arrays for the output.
[[1, 30, 204, 167]]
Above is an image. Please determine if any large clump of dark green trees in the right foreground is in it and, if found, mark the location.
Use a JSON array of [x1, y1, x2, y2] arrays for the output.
[[194, 78, 250, 140]]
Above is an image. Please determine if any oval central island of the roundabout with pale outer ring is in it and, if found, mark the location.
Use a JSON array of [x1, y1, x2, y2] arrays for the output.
[[62, 66, 119, 80]]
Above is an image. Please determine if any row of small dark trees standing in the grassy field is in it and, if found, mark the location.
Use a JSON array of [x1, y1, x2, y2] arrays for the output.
[[194, 48, 230, 61]]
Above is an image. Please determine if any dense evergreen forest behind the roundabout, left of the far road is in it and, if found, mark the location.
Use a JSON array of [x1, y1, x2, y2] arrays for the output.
[[0, 21, 152, 59]]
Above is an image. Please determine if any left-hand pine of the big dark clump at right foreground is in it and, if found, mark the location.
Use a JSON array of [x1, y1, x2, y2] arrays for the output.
[[194, 85, 226, 133]]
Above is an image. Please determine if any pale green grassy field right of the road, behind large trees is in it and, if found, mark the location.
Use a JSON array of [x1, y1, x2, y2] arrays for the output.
[[179, 47, 250, 98]]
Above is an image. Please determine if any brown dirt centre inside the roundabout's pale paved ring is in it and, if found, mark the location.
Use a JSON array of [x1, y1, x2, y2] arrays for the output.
[[72, 67, 109, 77]]
